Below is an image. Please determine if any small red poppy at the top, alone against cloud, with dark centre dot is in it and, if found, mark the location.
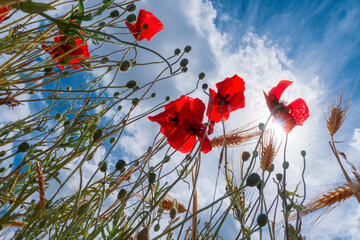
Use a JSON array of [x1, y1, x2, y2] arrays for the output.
[[125, 9, 164, 41]]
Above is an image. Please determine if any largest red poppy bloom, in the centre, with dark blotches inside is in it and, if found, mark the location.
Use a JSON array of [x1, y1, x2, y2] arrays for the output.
[[149, 95, 212, 153]]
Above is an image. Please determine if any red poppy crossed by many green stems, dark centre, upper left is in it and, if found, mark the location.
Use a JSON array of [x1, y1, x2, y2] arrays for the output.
[[41, 32, 90, 69]]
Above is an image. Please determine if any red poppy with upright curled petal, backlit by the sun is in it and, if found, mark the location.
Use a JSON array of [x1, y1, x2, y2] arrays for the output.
[[264, 80, 310, 133]]
